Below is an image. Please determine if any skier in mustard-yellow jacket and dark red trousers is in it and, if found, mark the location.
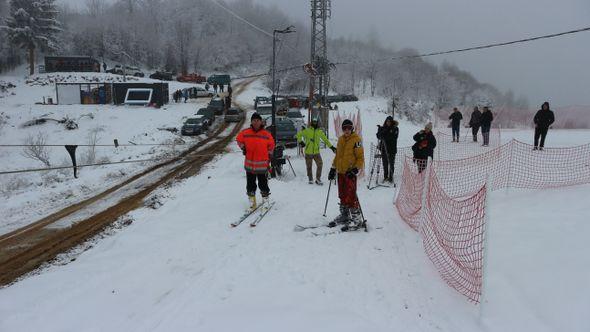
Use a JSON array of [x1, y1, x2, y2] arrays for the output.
[[328, 119, 365, 230]]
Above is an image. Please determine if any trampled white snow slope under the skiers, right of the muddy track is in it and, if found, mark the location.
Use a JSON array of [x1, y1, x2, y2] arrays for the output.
[[0, 78, 590, 332]]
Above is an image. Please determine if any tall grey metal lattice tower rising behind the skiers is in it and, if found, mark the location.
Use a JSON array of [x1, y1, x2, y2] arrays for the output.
[[308, 0, 332, 135]]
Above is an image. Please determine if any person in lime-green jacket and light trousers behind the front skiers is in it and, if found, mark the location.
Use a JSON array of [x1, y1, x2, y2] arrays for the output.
[[297, 119, 336, 186]]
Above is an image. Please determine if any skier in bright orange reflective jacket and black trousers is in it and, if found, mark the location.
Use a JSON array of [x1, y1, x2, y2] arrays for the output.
[[236, 113, 275, 209]]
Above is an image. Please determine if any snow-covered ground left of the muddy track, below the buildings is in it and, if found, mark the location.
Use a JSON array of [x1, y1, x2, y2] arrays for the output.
[[0, 73, 219, 234]]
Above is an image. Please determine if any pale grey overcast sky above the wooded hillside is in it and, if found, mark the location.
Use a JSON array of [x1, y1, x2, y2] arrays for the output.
[[255, 0, 590, 107]]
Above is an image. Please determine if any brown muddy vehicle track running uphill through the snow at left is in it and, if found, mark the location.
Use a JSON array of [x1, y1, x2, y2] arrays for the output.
[[0, 80, 252, 285]]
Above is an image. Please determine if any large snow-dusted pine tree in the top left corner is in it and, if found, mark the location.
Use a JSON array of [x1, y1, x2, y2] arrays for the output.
[[2, 0, 61, 75]]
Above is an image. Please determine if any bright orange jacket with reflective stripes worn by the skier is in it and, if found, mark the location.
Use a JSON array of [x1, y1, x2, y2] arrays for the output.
[[236, 127, 275, 173]]
